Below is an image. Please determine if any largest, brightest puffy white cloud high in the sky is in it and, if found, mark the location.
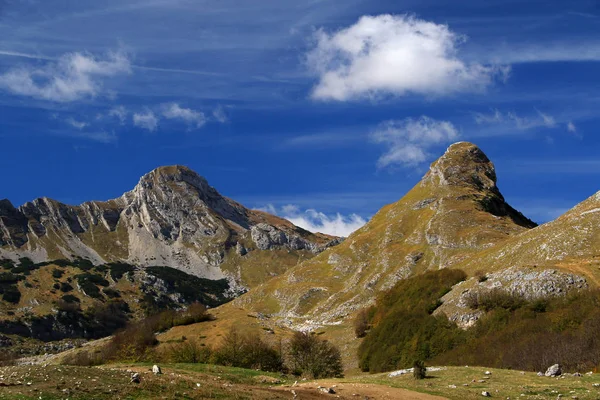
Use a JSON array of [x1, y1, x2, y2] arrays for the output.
[[307, 15, 510, 101]]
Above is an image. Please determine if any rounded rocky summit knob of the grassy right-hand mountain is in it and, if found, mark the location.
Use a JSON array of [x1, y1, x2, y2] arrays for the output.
[[425, 142, 496, 190]]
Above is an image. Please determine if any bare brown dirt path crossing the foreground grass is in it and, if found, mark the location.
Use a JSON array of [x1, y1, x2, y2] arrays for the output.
[[271, 381, 444, 400]]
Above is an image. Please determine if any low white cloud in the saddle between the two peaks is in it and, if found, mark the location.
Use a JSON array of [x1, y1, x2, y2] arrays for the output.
[[254, 204, 367, 237]]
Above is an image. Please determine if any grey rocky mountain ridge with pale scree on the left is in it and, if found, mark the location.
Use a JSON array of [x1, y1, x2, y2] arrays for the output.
[[0, 166, 339, 290]]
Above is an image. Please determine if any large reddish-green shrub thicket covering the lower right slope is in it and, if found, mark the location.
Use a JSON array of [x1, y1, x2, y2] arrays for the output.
[[358, 270, 600, 372]]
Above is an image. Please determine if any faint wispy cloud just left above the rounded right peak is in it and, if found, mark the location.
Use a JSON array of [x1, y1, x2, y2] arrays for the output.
[[371, 116, 459, 168]]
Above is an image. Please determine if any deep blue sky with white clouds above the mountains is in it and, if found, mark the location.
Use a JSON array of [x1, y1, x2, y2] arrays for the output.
[[0, 0, 600, 234]]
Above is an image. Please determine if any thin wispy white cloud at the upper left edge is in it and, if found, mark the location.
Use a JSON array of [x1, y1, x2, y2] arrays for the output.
[[0, 52, 131, 102]]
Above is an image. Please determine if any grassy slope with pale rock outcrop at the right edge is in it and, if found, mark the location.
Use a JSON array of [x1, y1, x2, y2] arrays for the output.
[[436, 192, 600, 327]]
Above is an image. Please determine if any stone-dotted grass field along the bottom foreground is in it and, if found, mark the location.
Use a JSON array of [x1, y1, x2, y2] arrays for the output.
[[0, 364, 600, 400]]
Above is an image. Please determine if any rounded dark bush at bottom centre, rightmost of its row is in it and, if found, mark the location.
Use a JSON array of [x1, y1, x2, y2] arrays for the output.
[[289, 332, 343, 379]]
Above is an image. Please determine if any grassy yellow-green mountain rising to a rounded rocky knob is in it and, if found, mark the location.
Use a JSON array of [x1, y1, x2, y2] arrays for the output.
[[233, 142, 536, 329]]
